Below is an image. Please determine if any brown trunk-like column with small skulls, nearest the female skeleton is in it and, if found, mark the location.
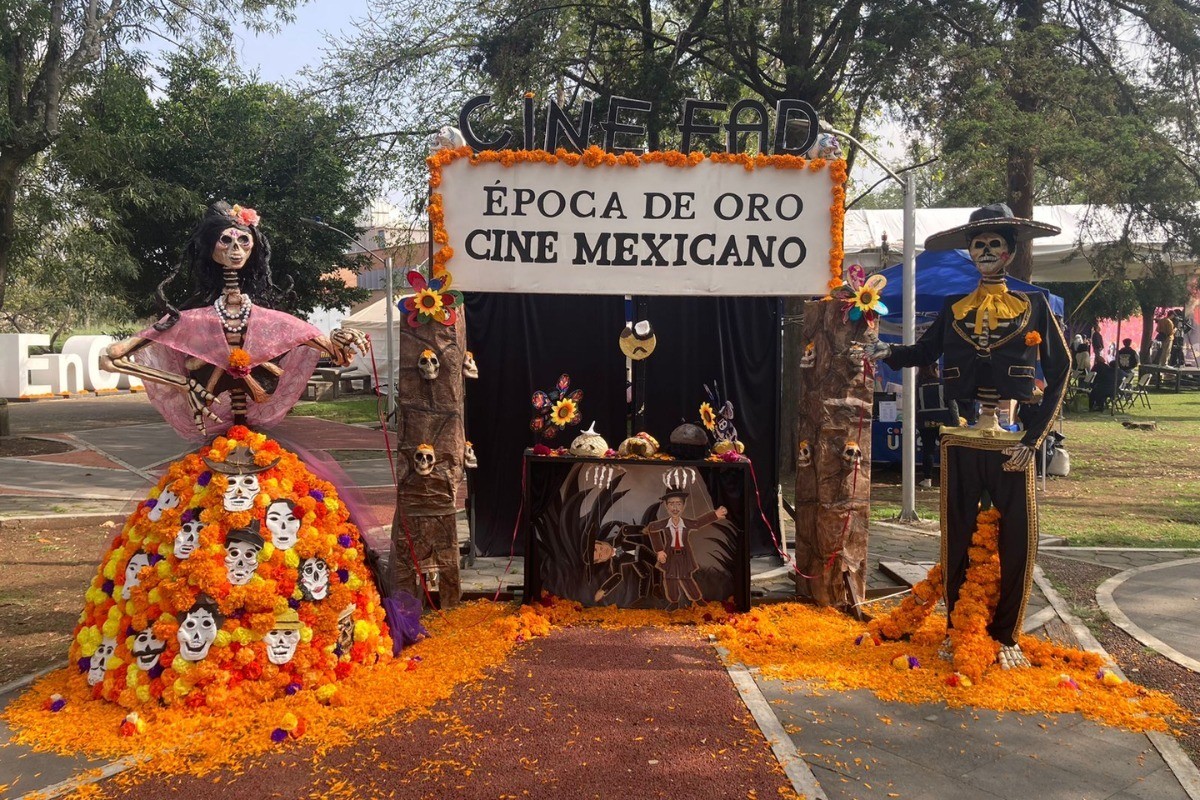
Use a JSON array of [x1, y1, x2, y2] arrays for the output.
[[390, 309, 467, 608]]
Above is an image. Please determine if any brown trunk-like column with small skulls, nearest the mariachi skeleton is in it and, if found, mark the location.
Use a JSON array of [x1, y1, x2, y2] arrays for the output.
[[796, 301, 874, 609]]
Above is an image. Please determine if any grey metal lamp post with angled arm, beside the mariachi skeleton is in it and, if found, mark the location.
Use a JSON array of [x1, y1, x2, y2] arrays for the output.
[[821, 120, 919, 522]]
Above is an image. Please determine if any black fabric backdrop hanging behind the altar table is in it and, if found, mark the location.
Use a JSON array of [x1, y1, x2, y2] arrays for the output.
[[466, 291, 781, 555]]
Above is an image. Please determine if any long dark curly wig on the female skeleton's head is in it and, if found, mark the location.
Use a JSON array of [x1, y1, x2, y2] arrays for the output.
[[155, 200, 287, 331]]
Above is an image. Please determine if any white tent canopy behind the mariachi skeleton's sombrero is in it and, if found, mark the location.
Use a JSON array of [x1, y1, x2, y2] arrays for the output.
[[842, 205, 1198, 283]]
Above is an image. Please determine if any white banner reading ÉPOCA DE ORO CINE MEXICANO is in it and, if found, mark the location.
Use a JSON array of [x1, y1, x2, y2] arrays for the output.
[[439, 158, 840, 295]]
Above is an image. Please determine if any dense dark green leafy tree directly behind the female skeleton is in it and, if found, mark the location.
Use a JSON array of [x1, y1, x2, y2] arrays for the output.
[[54, 53, 373, 313]]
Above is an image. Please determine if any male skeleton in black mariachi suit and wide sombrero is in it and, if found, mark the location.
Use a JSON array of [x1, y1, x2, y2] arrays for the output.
[[868, 204, 1070, 669]]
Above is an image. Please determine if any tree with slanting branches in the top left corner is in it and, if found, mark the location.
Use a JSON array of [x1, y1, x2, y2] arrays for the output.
[[0, 0, 296, 308]]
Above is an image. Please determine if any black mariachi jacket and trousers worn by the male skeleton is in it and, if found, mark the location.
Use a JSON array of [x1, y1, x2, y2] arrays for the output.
[[884, 281, 1070, 644]]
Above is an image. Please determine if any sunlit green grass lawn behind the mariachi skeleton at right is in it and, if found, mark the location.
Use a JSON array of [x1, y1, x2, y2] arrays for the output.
[[871, 391, 1200, 547]]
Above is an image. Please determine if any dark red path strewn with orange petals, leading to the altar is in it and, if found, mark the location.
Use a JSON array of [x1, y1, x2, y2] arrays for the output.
[[103, 627, 796, 800]]
